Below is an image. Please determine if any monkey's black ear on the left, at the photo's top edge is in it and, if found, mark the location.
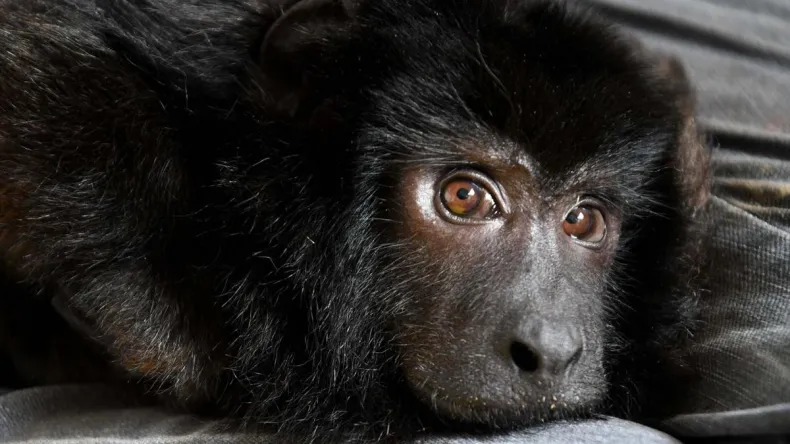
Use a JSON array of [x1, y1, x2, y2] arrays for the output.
[[259, 0, 360, 117]]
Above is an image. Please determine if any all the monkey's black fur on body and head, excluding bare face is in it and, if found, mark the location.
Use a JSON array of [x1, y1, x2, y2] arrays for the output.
[[0, 0, 707, 438]]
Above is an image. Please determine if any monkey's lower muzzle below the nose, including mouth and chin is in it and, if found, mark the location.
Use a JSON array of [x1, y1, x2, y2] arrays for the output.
[[403, 349, 607, 428]]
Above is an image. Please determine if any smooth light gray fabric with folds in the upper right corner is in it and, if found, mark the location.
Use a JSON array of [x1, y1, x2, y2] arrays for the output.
[[580, 0, 790, 144]]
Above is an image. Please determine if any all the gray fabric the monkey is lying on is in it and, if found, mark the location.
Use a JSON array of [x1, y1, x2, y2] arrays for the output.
[[0, 0, 790, 444]]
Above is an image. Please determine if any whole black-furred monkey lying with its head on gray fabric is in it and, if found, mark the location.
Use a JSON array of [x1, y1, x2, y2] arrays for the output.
[[0, 0, 708, 441]]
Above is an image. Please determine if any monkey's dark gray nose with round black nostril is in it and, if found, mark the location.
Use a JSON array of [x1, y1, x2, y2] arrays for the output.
[[508, 319, 583, 378]]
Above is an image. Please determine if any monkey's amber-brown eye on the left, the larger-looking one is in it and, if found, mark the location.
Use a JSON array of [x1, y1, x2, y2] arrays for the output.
[[440, 177, 495, 219]]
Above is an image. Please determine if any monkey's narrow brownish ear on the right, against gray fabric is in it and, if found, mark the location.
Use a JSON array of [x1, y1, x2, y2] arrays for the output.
[[657, 56, 710, 213]]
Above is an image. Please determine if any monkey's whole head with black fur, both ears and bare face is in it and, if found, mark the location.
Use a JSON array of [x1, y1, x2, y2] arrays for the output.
[[190, 0, 705, 434]]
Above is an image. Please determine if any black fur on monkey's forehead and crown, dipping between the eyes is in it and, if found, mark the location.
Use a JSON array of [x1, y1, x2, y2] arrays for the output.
[[350, 0, 681, 182]]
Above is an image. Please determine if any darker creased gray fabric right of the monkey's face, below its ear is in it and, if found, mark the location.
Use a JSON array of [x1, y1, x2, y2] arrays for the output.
[[685, 156, 790, 412]]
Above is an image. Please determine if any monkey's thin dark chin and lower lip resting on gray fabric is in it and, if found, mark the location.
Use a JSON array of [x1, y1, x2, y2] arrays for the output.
[[415, 388, 604, 430]]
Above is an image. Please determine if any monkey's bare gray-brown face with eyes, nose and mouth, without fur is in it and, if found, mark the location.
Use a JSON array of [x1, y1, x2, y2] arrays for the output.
[[398, 156, 621, 421]]
